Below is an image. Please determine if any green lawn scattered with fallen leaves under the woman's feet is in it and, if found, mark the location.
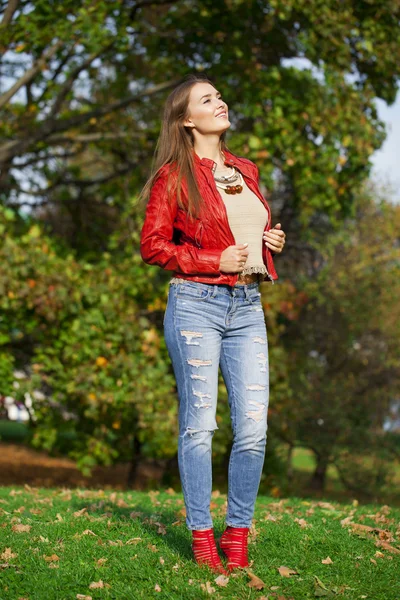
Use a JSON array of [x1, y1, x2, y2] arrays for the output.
[[0, 488, 400, 600]]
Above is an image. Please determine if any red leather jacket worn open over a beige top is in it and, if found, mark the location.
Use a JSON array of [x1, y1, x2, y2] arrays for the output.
[[140, 150, 278, 286]]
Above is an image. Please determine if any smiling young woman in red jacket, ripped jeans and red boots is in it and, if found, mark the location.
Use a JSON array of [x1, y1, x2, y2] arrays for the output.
[[141, 75, 285, 574]]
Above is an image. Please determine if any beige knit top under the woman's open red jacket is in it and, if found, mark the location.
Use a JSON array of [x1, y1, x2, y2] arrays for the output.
[[170, 168, 268, 283]]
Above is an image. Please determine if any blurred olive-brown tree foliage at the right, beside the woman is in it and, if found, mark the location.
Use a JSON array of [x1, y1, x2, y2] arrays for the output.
[[271, 190, 400, 494]]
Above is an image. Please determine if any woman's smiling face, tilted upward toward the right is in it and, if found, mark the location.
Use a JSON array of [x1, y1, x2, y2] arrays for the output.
[[184, 82, 231, 135]]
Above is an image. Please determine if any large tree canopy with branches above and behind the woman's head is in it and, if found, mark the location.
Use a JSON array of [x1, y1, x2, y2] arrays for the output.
[[0, 0, 400, 241]]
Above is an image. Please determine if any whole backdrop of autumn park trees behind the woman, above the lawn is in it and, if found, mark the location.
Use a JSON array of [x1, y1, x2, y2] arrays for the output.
[[0, 0, 400, 600]]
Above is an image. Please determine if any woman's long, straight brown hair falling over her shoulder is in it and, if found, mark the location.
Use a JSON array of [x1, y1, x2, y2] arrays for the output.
[[139, 75, 228, 217]]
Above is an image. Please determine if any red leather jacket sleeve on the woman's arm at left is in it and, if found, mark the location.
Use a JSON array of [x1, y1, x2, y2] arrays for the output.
[[140, 168, 222, 275]]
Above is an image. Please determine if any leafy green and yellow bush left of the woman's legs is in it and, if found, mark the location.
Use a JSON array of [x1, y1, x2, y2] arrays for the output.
[[0, 209, 176, 470]]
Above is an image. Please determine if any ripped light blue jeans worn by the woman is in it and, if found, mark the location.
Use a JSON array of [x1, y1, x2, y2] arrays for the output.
[[164, 281, 269, 529]]
